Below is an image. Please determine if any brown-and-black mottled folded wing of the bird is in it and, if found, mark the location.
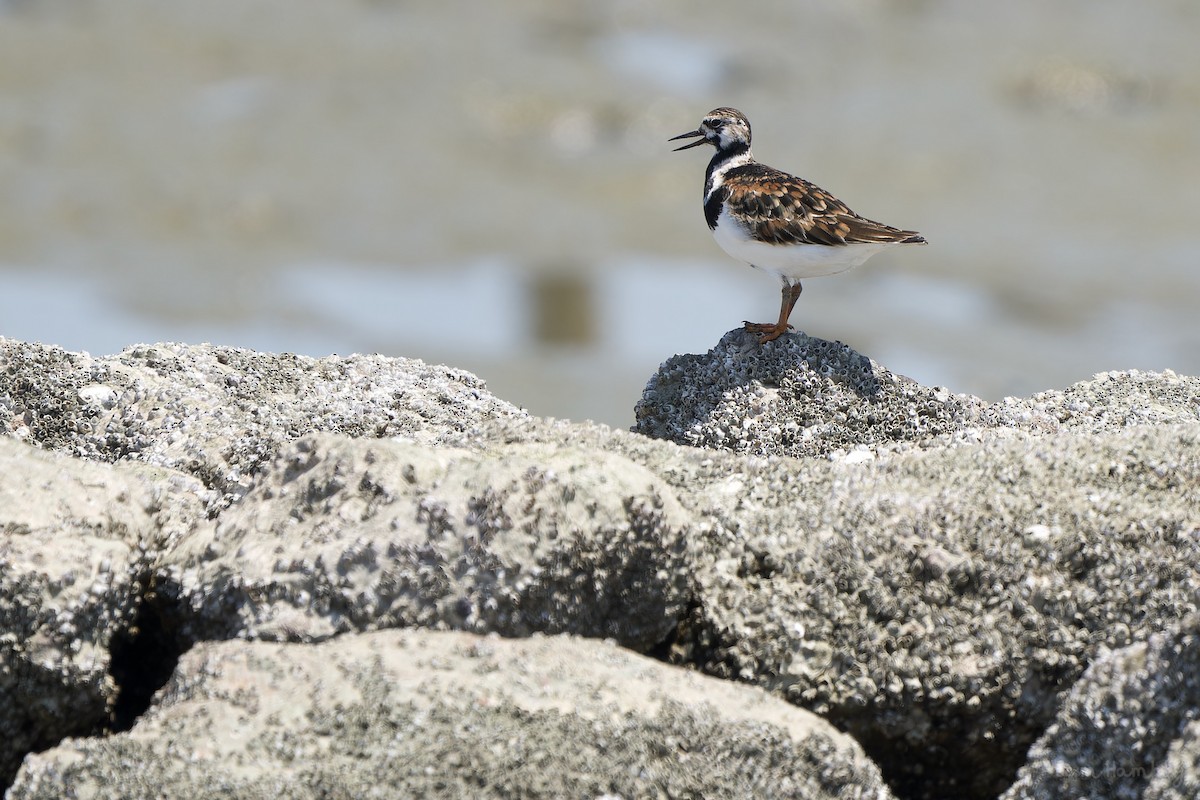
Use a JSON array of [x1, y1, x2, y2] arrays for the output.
[[721, 164, 925, 245]]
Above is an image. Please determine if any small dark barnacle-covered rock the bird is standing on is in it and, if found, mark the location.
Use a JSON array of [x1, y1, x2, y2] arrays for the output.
[[634, 329, 988, 457]]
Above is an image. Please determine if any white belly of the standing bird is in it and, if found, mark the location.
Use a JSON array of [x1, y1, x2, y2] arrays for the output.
[[713, 209, 888, 283]]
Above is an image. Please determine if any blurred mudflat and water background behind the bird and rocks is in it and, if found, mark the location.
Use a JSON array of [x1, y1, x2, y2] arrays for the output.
[[0, 0, 1200, 427]]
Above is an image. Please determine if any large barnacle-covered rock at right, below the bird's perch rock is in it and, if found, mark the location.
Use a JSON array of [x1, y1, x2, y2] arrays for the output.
[[652, 425, 1200, 798]]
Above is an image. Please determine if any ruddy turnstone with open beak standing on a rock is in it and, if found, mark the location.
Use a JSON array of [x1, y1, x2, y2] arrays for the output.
[[668, 108, 925, 343]]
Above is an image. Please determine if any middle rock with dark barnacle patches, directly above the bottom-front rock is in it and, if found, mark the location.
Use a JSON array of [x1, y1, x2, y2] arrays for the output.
[[160, 434, 691, 650]]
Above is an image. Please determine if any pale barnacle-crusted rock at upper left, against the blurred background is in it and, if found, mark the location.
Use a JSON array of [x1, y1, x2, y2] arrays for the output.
[[0, 337, 524, 503]]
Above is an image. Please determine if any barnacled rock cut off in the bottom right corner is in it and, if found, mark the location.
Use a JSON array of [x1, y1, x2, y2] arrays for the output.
[[1003, 616, 1200, 800]]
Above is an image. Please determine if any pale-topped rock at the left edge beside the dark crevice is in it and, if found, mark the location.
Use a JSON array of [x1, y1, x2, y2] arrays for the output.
[[0, 437, 204, 786]]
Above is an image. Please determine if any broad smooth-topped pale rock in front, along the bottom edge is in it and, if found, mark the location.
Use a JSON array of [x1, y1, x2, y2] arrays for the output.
[[7, 631, 892, 800]]
